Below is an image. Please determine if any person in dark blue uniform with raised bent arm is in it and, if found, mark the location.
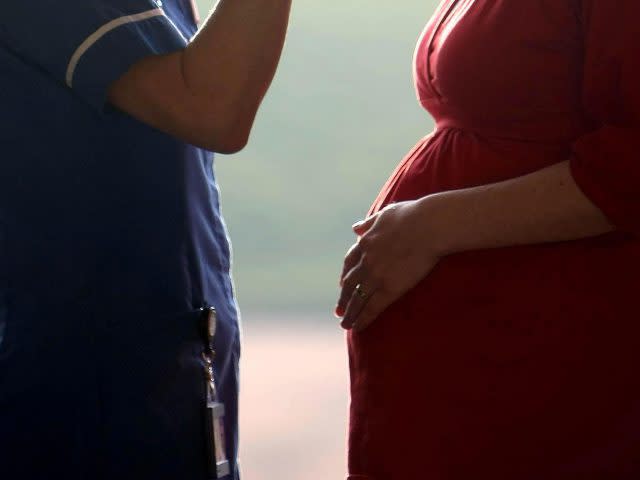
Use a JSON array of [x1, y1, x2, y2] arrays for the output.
[[0, 0, 290, 480]]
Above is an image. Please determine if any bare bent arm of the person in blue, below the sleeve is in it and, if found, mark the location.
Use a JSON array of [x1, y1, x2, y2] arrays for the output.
[[109, 0, 291, 153]]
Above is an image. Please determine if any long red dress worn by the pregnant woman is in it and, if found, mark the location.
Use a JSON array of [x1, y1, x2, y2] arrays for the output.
[[348, 0, 640, 480]]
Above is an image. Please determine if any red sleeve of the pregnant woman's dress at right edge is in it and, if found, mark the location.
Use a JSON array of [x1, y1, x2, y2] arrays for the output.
[[571, 0, 640, 235]]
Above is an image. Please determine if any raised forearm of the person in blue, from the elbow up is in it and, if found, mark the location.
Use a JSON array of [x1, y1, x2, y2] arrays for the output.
[[182, 0, 291, 144]]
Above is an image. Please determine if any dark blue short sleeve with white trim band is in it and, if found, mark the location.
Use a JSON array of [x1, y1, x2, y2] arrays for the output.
[[0, 0, 186, 109]]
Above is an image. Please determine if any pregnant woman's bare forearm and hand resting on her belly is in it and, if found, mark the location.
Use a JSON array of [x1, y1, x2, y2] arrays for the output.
[[336, 161, 615, 331]]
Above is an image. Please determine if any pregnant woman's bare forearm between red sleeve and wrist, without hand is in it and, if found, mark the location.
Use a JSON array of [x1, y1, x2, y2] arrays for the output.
[[418, 161, 613, 255]]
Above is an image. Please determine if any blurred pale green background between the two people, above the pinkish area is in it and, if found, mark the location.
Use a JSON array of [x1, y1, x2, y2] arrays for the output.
[[199, 0, 438, 313]]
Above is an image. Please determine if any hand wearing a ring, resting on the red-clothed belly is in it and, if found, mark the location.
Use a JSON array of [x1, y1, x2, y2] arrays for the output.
[[335, 197, 442, 331]]
